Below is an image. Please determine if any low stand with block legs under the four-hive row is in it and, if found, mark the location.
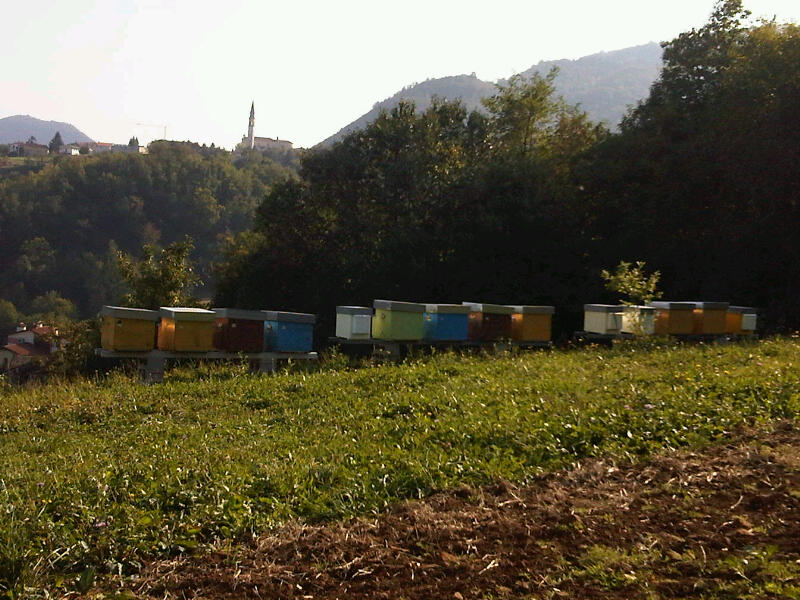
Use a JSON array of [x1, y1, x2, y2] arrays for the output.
[[95, 348, 318, 383]]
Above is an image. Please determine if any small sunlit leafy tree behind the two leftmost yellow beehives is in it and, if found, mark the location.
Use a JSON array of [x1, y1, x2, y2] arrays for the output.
[[118, 236, 201, 310]]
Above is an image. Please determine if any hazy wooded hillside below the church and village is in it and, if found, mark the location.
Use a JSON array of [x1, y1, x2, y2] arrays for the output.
[[0, 142, 293, 322]]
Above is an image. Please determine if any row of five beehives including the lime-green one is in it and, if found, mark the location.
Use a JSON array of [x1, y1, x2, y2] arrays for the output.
[[336, 300, 555, 342]]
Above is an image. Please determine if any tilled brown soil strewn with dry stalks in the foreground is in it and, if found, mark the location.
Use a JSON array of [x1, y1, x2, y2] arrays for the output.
[[120, 423, 800, 599]]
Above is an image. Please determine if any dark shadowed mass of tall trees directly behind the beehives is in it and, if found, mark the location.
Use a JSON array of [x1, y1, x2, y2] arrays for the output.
[[217, 0, 800, 331]]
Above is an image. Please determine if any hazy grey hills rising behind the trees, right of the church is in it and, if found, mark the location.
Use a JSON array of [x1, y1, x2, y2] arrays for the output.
[[320, 42, 662, 146]]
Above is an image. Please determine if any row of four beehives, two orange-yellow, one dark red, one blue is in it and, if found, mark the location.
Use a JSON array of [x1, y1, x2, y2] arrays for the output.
[[100, 306, 316, 353]]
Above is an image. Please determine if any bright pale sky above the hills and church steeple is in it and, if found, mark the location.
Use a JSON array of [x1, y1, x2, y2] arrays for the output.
[[0, 0, 800, 149]]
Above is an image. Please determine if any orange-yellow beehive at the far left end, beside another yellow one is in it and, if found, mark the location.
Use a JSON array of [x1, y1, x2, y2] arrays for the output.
[[100, 306, 159, 352]]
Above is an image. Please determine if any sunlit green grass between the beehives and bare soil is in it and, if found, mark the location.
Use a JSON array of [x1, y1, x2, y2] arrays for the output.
[[0, 340, 800, 598]]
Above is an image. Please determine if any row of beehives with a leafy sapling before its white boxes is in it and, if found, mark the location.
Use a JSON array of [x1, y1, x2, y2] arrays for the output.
[[583, 302, 757, 335]]
